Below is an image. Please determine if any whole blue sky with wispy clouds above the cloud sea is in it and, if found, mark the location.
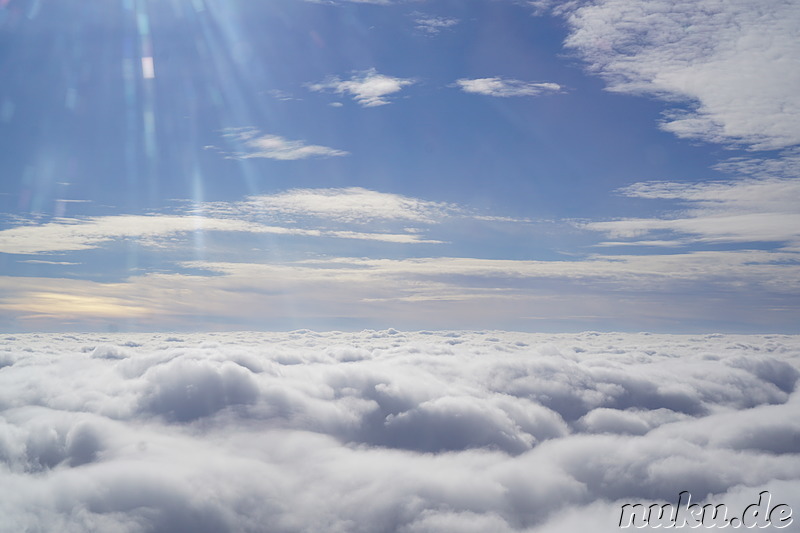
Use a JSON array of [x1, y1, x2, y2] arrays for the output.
[[0, 0, 800, 332]]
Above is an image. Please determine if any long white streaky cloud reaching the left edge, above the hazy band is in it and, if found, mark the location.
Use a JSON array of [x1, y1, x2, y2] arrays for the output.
[[0, 187, 476, 255]]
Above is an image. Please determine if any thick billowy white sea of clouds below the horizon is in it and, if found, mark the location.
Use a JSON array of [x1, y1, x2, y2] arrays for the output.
[[0, 330, 800, 533]]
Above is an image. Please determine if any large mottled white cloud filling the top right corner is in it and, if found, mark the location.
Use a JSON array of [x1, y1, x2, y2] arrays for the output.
[[563, 0, 800, 150]]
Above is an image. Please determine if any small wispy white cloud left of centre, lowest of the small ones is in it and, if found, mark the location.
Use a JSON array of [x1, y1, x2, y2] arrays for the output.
[[217, 128, 349, 161]]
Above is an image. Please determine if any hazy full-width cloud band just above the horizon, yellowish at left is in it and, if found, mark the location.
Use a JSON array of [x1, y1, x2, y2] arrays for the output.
[[0, 244, 800, 328]]
